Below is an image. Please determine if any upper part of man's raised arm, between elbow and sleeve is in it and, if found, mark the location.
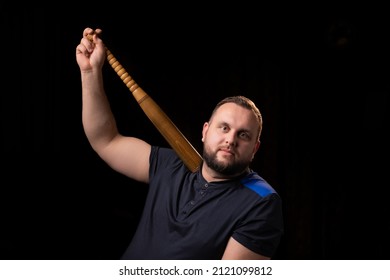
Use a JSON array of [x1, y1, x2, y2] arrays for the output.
[[99, 135, 151, 183]]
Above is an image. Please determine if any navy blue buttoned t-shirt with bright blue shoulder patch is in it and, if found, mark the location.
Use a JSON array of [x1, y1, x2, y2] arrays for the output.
[[122, 146, 283, 260]]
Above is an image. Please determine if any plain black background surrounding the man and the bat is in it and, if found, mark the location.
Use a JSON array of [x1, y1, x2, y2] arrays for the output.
[[0, 5, 390, 259]]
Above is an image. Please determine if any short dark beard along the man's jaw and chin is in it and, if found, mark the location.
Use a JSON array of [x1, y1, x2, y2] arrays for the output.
[[203, 147, 250, 176]]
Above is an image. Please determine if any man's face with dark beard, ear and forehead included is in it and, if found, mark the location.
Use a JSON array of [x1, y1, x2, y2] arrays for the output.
[[202, 103, 260, 176]]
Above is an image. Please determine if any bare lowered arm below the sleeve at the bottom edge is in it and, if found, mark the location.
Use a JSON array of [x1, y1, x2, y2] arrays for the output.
[[222, 237, 270, 260]]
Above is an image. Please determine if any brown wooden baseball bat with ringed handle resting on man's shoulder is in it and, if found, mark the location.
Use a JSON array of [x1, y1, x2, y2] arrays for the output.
[[89, 35, 202, 172]]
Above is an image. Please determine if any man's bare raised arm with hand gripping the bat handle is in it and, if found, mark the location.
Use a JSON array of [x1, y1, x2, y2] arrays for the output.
[[76, 28, 151, 183]]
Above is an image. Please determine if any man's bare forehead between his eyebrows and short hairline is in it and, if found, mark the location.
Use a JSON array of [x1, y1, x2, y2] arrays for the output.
[[212, 103, 258, 129]]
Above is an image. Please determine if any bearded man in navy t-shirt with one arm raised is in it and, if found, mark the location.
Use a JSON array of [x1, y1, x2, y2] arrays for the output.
[[76, 28, 283, 260]]
